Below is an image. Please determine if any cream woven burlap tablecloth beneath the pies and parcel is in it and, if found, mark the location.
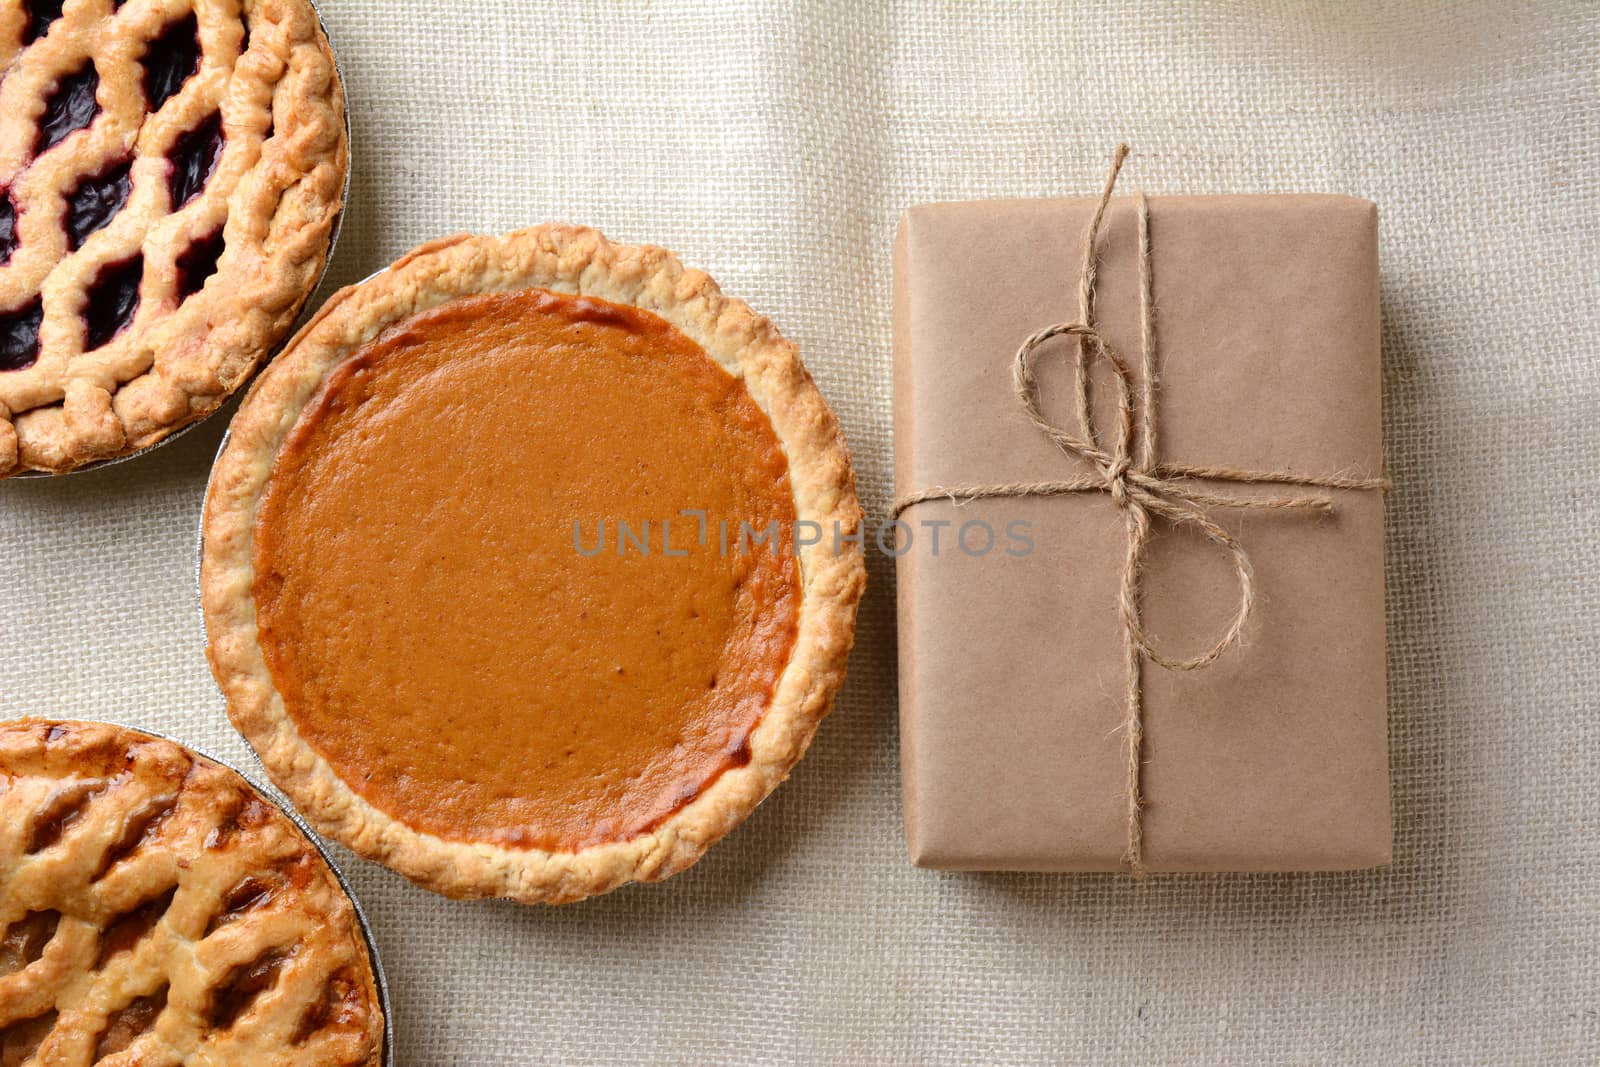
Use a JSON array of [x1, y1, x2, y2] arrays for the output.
[[0, 0, 1600, 1065]]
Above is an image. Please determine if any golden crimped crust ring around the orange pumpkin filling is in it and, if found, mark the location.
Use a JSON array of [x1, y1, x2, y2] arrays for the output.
[[202, 224, 866, 904]]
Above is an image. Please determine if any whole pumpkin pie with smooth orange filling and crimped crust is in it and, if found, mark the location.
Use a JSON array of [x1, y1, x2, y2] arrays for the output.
[[202, 226, 864, 902]]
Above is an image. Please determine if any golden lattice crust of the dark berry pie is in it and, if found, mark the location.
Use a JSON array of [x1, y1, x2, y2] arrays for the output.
[[0, 0, 349, 477]]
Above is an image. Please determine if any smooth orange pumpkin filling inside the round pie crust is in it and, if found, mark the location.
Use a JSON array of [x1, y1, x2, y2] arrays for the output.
[[251, 290, 800, 849]]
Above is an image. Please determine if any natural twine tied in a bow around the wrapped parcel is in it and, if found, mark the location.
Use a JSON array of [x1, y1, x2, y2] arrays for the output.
[[894, 144, 1389, 877]]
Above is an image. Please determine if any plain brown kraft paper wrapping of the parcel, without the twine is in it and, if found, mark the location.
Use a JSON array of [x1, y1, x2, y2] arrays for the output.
[[894, 195, 1390, 870]]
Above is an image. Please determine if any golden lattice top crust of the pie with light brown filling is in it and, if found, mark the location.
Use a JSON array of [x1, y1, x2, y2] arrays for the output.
[[0, 718, 384, 1067]]
